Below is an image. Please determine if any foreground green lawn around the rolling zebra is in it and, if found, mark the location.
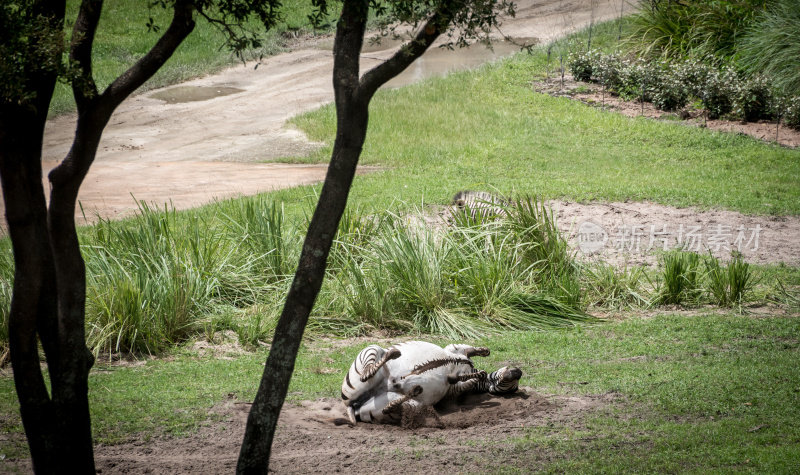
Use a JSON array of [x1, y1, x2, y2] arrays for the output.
[[0, 313, 800, 473]]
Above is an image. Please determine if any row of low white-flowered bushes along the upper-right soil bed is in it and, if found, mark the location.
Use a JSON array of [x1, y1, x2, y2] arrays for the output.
[[568, 50, 800, 129]]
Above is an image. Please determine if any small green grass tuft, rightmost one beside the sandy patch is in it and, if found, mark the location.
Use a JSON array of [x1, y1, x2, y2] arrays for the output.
[[705, 255, 755, 307]]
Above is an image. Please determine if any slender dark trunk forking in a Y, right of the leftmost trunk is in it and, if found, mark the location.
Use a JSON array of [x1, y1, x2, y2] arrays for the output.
[[42, 0, 194, 471]]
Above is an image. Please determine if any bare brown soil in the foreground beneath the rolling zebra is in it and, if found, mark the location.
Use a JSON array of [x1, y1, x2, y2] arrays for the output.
[[86, 388, 619, 474]]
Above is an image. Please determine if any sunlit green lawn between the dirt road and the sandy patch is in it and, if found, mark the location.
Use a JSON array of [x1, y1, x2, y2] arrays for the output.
[[292, 45, 800, 215]]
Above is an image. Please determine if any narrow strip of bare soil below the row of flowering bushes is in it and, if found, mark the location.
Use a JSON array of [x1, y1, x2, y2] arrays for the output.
[[533, 75, 800, 148]]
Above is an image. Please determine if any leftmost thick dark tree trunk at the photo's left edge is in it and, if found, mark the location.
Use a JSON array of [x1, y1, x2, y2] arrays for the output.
[[0, 1, 75, 473]]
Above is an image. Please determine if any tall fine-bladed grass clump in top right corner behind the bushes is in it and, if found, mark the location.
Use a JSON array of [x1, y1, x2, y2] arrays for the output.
[[737, 0, 800, 96]]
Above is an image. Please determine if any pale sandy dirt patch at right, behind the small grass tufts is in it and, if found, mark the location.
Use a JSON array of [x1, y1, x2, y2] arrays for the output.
[[548, 201, 800, 266]]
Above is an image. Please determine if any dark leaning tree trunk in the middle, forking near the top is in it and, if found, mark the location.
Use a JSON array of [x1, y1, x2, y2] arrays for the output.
[[236, 0, 463, 474]]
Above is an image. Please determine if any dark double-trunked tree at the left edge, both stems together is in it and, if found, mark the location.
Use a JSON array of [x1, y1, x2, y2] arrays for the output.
[[0, 0, 194, 473]]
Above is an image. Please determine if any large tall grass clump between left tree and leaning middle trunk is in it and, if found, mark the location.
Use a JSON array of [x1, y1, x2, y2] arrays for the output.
[[84, 204, 265, 353]]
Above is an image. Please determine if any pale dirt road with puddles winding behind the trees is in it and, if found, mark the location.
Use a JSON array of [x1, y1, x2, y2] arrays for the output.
[[6, 0, 621, 223]]
